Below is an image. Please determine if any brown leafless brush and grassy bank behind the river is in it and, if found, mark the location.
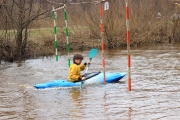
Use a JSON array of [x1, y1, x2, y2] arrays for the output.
[[0, 0, 180, 62]]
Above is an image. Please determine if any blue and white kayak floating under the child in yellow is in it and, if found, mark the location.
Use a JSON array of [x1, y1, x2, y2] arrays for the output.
[[34, 72, 126, 89]]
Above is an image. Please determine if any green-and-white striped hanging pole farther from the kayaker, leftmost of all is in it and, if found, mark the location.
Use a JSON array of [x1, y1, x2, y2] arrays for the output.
[[52, 6, 58, 61]]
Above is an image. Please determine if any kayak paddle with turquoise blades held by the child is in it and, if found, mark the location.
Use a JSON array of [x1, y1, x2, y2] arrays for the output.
[[81, 48, 98, 88]]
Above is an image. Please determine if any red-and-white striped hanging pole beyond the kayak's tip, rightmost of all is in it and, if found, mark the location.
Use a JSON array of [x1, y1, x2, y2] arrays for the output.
[[126, 0, 131, 91]]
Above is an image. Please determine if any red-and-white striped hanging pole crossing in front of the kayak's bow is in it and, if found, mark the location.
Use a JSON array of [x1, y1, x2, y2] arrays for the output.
[[99, 1, 106, 84]]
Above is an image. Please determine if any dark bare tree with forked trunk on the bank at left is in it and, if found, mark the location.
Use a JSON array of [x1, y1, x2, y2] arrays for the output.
[[2, 0, 50, 61]]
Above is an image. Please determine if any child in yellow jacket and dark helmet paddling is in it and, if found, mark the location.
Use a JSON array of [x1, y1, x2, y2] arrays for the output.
[[68, 54, 90, 82]]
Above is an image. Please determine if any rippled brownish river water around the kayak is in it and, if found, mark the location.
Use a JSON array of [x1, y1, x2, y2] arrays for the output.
[[0, 44, 180, 120]]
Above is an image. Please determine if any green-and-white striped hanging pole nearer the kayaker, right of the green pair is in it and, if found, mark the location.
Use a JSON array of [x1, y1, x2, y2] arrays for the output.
[[64, 5, 71, 67]]
